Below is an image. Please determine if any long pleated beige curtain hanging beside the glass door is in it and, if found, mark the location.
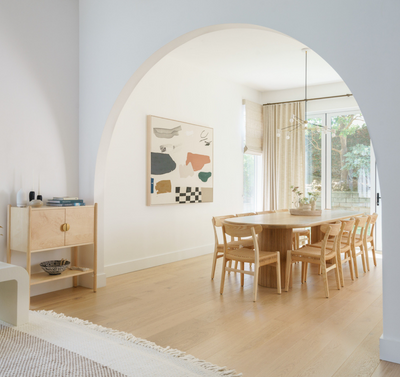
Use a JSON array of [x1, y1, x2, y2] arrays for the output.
[[263, 102, 305, 210]]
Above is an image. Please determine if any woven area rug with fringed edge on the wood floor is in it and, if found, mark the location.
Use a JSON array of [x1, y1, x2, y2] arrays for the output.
[[0, 311, 241, 377]]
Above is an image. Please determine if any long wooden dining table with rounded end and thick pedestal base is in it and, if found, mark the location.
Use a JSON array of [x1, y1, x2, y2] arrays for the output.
[[225, 210, 364, 288]]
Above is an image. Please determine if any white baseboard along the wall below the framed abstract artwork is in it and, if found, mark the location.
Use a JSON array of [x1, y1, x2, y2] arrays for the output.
[[104, 244, 214, 277]]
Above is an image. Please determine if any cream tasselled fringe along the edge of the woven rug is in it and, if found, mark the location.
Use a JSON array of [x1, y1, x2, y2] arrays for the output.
[[36, 310, 243, 377]]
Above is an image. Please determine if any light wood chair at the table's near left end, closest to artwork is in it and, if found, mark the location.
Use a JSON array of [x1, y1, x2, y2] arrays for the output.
[[220, 223, 281, 302]]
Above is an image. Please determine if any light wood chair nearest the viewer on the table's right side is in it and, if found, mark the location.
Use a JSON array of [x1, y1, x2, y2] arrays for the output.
[[285, 222, 341, 298]]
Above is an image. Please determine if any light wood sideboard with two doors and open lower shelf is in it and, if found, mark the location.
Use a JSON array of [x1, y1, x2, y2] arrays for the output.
[[7, 204, 97, 292]]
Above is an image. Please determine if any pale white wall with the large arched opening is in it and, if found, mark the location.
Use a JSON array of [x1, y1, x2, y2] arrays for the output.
[[80, 0, 400, 362]]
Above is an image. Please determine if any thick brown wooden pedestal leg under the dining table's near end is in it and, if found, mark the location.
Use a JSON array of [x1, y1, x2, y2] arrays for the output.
[[258, 228, 292, 288]]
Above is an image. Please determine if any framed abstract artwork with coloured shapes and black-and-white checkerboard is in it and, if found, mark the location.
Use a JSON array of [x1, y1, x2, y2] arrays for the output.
[[147, 115, 214, 205]]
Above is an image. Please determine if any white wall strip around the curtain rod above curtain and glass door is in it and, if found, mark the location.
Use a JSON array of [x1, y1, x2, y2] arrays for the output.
[[261, 82, 358, 112]]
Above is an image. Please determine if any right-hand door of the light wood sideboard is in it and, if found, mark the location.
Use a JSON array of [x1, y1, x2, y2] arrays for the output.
[[65, 207, 94, 246]]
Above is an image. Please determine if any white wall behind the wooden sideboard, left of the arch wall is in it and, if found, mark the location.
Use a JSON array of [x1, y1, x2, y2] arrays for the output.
[[0, 0, 78, 295]]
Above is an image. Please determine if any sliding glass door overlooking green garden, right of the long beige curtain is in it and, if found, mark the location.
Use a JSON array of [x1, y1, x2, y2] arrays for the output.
[[306, 111, 375, 213]]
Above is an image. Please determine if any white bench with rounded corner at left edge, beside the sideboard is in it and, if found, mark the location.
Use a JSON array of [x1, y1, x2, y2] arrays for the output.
[[0, 262, 29, 326]]
